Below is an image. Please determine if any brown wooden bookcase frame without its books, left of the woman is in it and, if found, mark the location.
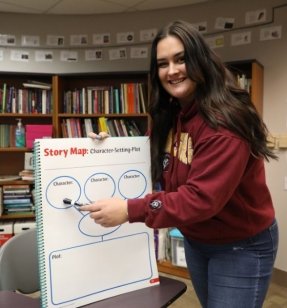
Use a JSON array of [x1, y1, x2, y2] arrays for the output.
[[0, 72, 149, 222]]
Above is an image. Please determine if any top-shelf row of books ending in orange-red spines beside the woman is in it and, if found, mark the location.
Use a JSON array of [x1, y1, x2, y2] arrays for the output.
[[64, 83, 147, 114]]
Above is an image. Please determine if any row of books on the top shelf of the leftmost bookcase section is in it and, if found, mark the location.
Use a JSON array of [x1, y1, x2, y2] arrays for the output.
[[0, 83, 52, 114]]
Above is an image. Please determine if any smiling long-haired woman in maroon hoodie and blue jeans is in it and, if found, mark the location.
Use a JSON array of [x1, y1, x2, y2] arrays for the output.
[[83, 21, 278, 308]]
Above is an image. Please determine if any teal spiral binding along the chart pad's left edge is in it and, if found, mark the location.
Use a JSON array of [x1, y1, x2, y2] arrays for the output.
[[34, 141, 47, 308]]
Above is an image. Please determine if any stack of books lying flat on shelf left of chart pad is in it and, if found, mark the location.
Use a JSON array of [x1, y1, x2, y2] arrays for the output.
[[0, 184, 34, 215]]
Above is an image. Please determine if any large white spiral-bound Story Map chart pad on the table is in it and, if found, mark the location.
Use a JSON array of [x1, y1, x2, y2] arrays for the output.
[[34, 137, 159, 308]]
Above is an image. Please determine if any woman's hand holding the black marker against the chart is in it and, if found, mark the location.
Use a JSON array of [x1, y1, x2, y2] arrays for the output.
[[80, 198, 128, 227]]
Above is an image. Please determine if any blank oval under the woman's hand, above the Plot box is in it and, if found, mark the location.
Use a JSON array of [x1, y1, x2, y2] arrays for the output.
[[78, 213, 120, 237]]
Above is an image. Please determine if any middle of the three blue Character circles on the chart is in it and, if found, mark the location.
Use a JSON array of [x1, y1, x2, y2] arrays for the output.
[[84, 173, 116, 202]]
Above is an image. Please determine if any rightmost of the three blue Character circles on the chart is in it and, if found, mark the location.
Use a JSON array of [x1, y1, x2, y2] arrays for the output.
[[118, 170, 147, 199]]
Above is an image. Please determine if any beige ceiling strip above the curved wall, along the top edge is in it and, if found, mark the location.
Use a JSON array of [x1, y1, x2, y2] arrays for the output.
[[0, 0, 213, 15]]
